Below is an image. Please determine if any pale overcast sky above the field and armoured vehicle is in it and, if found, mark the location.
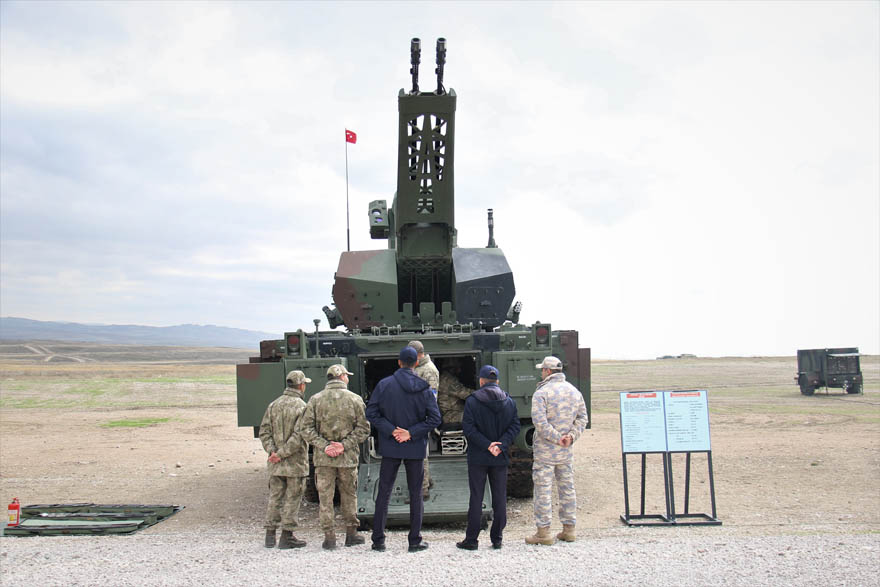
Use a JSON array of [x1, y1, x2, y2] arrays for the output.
[[0, 1, 880, 359]]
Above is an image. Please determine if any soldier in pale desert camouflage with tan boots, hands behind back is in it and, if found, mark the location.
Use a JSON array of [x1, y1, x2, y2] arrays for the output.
[[526, 357, 589, 545]]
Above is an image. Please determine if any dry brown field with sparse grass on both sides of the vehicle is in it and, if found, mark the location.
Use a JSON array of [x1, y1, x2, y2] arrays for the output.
[[0, 342, 880, 540]]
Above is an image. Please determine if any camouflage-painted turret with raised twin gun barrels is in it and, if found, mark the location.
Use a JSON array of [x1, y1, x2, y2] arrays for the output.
[[324, 39, 515, 331]]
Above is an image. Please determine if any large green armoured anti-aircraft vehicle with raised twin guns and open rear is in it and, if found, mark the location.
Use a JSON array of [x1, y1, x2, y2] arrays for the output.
[[237, 39, 590, 523]]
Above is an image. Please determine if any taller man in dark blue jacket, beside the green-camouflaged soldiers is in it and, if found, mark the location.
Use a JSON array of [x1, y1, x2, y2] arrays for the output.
[[367, 347, 440, 552]]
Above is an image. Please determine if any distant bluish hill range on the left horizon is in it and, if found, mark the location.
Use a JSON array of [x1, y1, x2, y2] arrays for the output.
[[0, 317, 281, 349]]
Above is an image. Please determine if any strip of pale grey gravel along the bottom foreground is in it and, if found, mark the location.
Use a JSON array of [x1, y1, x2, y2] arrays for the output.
[[0, 527, 880, 587]]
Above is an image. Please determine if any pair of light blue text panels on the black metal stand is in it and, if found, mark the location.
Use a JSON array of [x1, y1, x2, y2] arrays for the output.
[[620, 390, 712, 453]]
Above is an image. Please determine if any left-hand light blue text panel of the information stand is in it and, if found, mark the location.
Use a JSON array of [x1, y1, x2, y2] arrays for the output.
[[620, 391, 666, 453]]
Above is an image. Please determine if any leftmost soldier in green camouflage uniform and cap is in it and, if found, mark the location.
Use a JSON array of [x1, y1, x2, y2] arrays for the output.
[[260, 371, 312, 549]]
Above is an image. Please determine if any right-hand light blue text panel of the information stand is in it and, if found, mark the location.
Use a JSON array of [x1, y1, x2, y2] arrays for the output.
[[663, 390, 712, 452]]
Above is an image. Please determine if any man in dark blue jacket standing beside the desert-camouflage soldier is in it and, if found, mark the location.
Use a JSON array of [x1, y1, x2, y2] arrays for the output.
[[455, 365, 520, 550]]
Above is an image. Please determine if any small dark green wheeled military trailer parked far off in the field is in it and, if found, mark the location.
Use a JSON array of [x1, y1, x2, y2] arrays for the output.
[[794, 347, 862, 395]]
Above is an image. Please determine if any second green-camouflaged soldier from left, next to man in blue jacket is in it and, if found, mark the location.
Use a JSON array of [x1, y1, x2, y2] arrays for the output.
[[297, 365, 370, 550]]
